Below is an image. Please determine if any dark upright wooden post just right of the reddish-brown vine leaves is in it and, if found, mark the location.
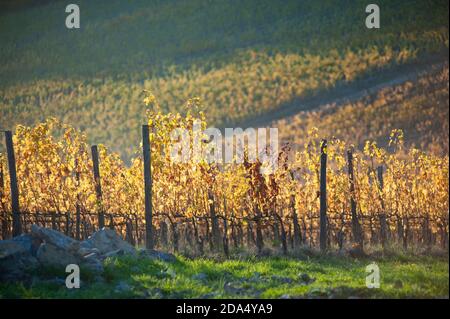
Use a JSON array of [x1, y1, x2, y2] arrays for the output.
[[319, 140, 328, 252]]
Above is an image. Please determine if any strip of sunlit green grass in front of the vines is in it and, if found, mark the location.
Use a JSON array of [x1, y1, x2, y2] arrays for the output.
[[0, 255, 449, 298]]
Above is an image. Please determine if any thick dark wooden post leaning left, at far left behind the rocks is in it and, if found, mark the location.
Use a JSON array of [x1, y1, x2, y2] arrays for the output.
[[5, 131, 22, 237]]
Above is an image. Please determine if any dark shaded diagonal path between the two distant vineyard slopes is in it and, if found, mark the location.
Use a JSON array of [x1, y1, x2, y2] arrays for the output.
[[234, 51, 449, 128]]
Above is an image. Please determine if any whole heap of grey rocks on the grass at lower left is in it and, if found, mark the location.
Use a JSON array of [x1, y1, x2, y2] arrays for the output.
[[0, 225, 177, 282]]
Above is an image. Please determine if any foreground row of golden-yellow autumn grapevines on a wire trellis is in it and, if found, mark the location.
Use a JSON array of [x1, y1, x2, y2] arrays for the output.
[[0, 113, 448, 255]]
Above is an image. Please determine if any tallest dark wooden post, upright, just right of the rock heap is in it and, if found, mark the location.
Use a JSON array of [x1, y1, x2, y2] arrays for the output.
[[142, 125, 153, 249]]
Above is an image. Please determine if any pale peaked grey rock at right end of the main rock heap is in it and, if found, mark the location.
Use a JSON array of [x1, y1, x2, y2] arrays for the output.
[[81, 228, 136, 255]]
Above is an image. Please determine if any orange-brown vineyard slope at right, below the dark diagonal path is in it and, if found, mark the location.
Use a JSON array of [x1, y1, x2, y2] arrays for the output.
[[269, 63, 449, 155]]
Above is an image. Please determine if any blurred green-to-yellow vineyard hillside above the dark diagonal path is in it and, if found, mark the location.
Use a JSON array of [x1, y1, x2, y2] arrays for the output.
[[0, 0, 448, 159]]
